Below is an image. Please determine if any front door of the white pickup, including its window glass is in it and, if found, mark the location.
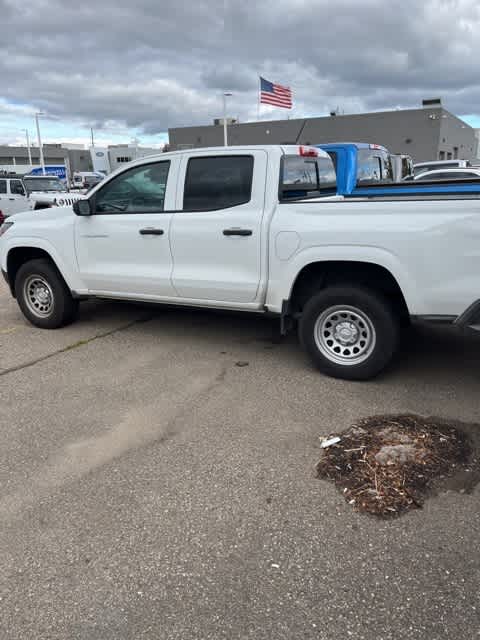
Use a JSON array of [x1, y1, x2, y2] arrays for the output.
[[75, 158, 179, 299]]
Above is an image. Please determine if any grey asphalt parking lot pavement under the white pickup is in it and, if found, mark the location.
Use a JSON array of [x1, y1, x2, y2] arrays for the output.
[[0, 283, 480, 640]]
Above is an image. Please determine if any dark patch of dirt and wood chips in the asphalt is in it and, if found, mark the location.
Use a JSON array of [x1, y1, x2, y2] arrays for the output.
[[317, 415, 480, 517]]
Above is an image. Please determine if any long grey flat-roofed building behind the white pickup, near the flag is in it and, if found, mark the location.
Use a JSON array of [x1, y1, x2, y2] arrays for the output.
[[168, 99, 478, 162]]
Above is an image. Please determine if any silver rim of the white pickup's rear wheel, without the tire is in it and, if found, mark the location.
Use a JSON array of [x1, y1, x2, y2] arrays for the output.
[[314, 304, 377, 366]]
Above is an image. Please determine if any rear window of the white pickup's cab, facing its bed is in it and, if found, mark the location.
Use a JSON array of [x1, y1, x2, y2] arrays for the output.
[[280, 155, 337, 200]]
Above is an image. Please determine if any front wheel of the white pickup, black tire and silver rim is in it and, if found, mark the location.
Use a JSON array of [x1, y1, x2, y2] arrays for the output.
[[15, 258, 78, 329]]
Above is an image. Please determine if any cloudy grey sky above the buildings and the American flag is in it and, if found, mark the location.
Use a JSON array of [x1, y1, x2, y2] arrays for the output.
[[0, 0, 480, 144]]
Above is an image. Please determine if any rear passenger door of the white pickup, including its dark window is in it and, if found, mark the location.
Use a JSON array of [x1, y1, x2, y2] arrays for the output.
[[170, 149, 268, 304]]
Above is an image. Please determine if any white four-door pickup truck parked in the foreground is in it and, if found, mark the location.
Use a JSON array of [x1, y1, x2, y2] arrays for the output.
[[0, 146, 480, 379]]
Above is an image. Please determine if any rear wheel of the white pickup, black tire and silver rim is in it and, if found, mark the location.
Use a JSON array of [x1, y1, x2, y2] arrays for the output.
[[298, 285, 400, 380]]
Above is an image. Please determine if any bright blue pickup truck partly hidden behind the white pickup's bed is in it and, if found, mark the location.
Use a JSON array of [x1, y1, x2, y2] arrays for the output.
[[315, 142, 480, 198]]
